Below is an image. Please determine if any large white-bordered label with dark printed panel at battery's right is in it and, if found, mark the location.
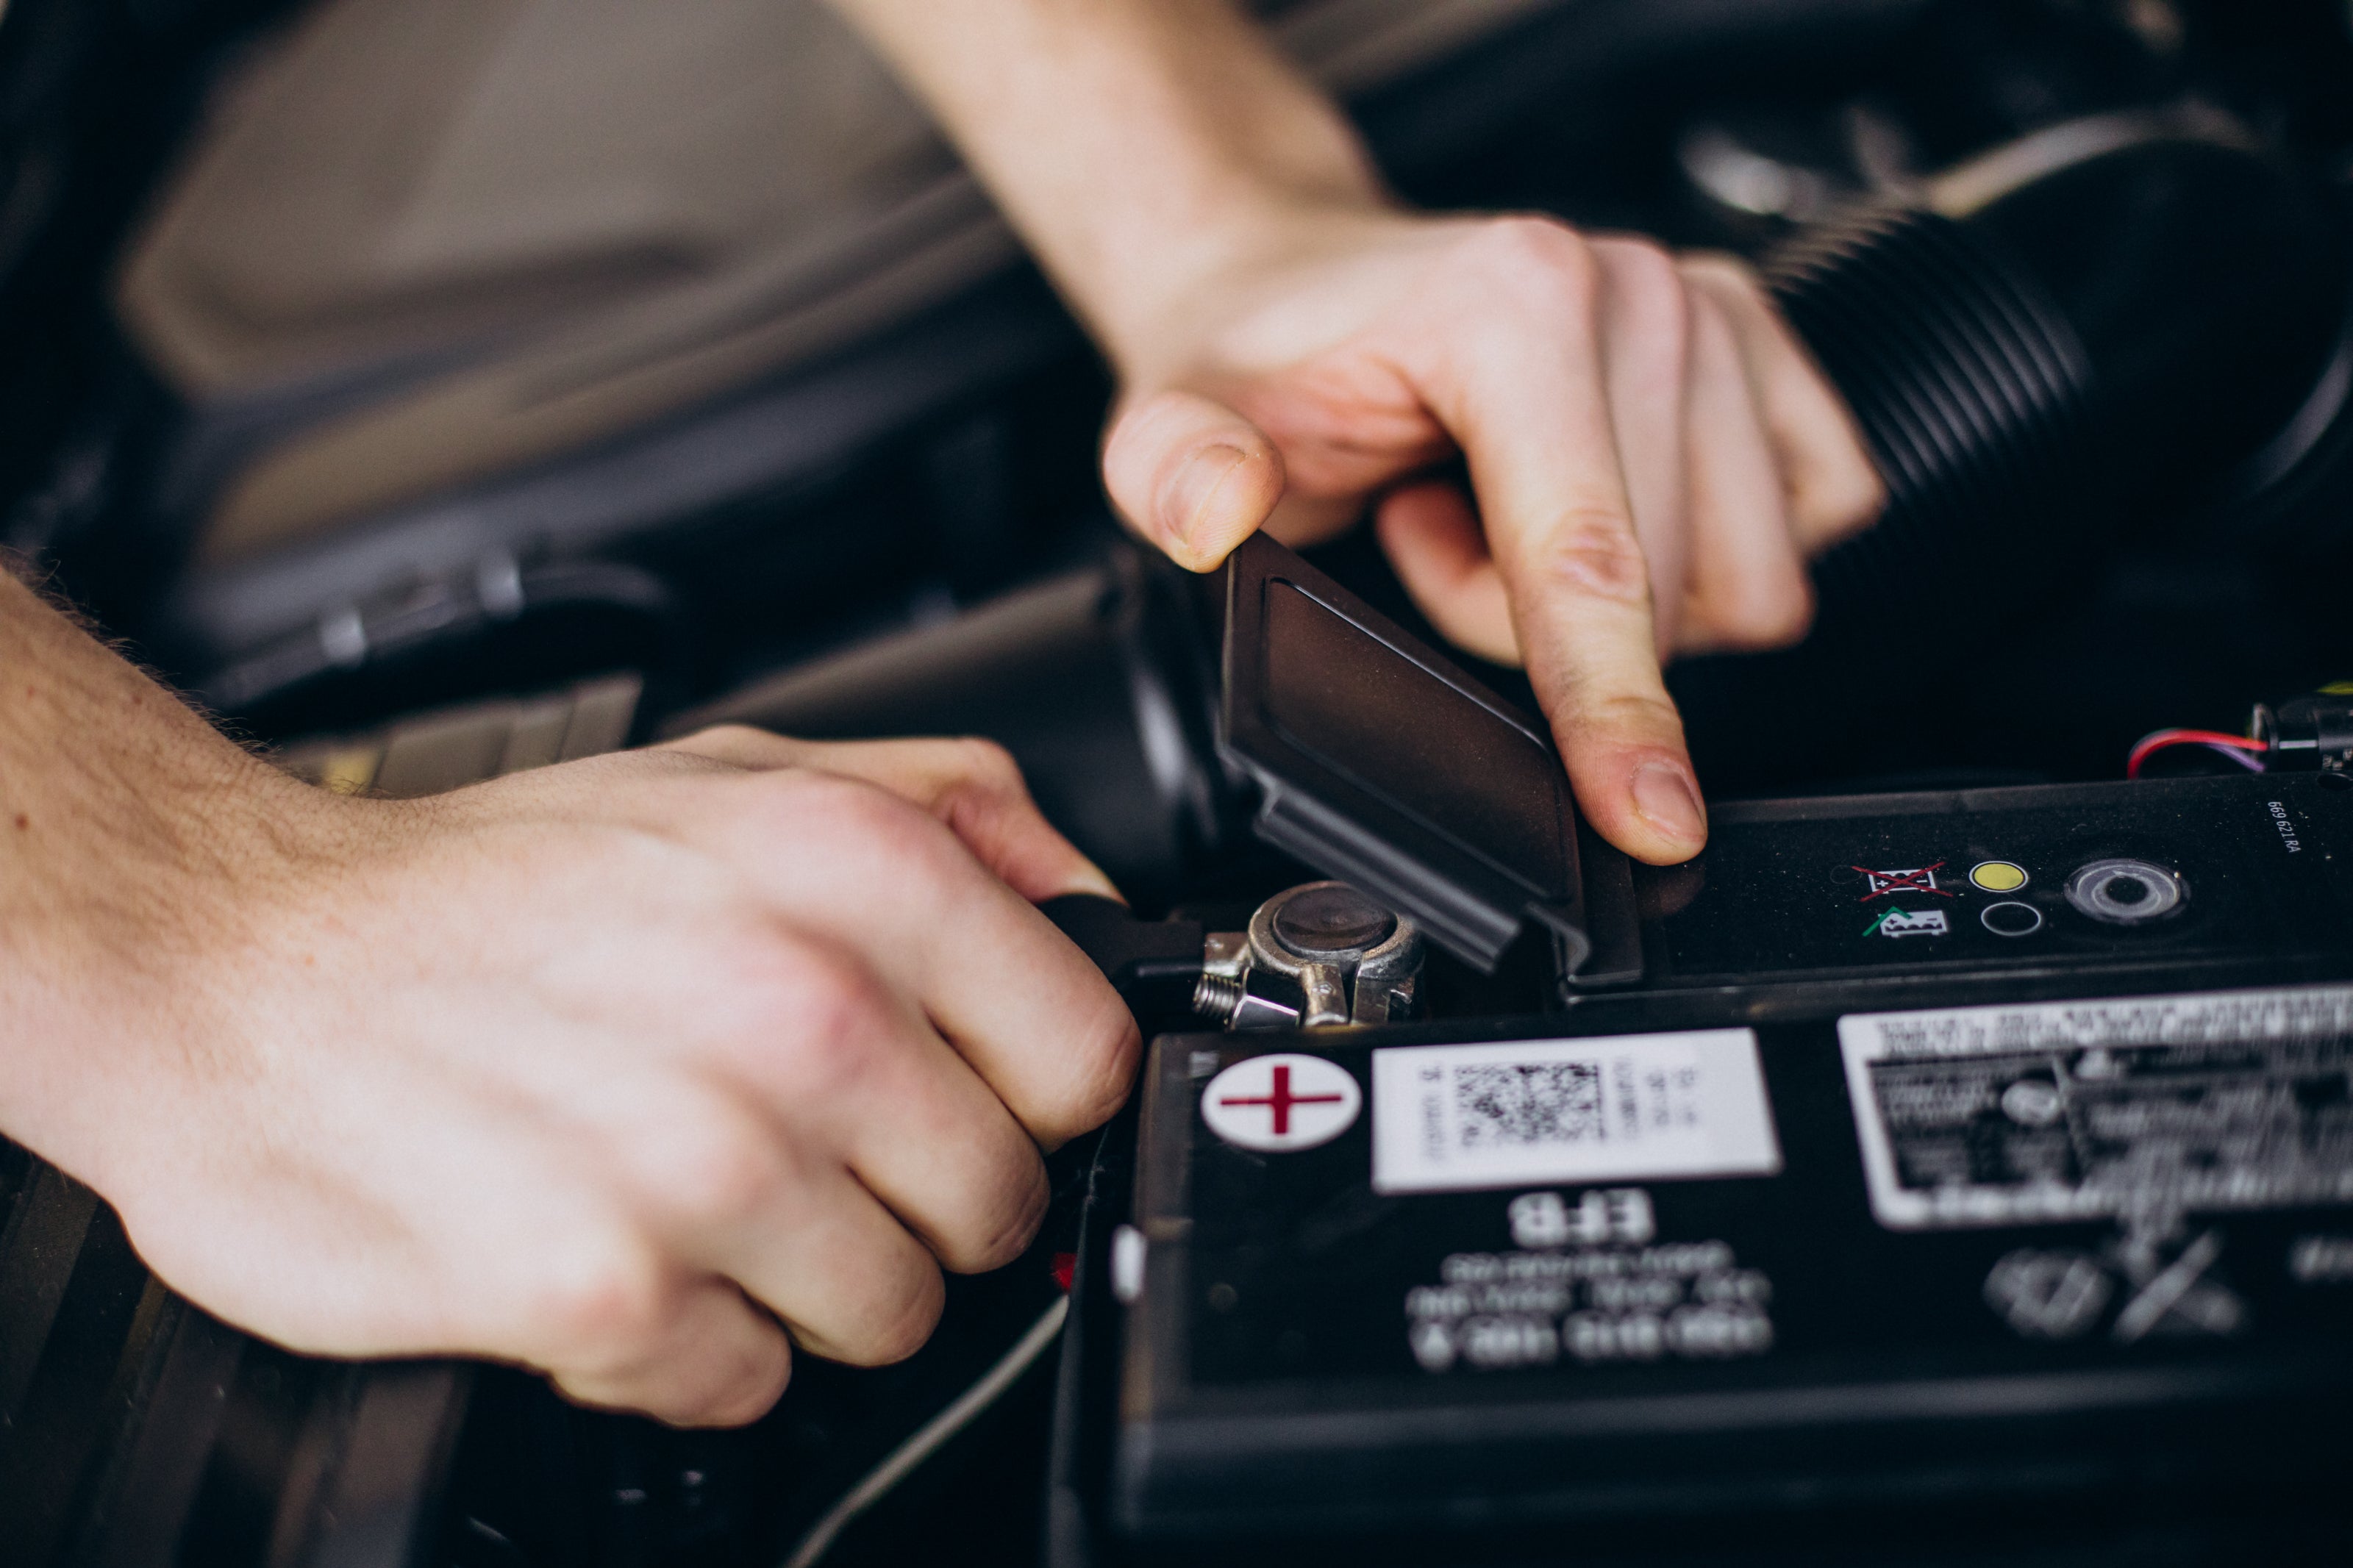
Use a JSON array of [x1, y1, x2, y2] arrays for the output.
[[1838, 985, 2353, 1230]]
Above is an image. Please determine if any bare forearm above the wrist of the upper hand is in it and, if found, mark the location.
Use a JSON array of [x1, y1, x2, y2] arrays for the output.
[[833, 0, 1386, 371]]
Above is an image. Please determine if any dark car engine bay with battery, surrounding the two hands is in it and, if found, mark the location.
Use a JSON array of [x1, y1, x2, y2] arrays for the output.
[[0, 0, 2353, 1568]]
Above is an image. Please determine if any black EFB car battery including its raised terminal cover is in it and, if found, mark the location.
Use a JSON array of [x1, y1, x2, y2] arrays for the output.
[[1054, 545, 2353, 1561]]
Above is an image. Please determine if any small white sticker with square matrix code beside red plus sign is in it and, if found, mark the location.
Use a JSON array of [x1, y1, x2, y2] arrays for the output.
[[1372, 1030, 1781, 1192]]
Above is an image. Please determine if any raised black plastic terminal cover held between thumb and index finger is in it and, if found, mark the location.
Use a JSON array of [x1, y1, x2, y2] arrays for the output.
[[1219, 534, 1590, 973]]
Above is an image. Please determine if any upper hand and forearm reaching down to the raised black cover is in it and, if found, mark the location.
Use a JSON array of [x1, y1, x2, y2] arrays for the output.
[[835, 0, 1880, 863]]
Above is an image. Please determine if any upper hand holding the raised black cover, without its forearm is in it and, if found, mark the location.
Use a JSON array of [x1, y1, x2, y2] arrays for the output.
[[1104, 210, 1882, 865]]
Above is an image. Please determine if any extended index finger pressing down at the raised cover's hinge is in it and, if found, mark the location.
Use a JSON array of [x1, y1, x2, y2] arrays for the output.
[[1400, 218, 1706, 865]]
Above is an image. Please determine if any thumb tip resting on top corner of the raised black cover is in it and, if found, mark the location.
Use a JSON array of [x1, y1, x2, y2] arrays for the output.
[[1104, 393, 1282, 571]]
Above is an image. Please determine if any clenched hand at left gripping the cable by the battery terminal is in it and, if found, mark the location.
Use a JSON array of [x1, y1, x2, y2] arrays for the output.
[[16, 728, 1139, 1425]]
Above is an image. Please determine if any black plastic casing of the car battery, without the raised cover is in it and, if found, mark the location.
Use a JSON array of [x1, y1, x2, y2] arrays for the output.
[[1057, 776, 2353, 1558]]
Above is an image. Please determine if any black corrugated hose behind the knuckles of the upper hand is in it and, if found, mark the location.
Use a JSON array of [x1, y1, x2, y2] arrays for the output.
[[1769, 120, 2349, 533]]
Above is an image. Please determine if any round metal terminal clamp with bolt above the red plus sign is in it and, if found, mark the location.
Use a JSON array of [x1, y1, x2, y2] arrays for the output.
[[1193, 881, 1421, 1030]]
